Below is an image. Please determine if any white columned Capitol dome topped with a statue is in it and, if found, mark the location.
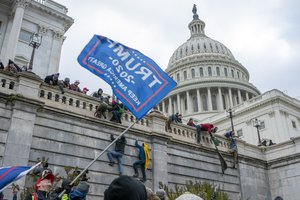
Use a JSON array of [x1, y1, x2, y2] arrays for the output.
[[158, 5, 260, 120]]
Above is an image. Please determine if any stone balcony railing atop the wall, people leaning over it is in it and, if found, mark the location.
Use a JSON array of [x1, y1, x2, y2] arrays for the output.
[[0, 71, 229, 152]]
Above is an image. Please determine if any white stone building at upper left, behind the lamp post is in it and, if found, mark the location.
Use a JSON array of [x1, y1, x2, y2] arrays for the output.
[[0, 0, 74, 78]]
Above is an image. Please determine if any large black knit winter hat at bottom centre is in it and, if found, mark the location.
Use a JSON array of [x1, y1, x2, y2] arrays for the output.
[[104, 176, 147, 200]]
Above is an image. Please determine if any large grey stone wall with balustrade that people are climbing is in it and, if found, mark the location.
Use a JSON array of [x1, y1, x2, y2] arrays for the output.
[[0, 72, 300, 200]]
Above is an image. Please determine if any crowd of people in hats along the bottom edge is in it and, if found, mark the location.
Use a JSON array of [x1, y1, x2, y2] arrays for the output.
[[0, 163, 167, 200]]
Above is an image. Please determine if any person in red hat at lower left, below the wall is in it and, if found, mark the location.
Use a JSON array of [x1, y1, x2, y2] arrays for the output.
[[26, 170, 55, 200]]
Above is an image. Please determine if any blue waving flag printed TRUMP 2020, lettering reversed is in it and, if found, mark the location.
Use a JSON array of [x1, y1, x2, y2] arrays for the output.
[[77, 35, 176, 119]]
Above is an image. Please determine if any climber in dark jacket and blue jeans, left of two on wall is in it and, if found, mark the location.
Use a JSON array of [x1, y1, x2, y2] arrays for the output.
[[107, 134, 127, 175]]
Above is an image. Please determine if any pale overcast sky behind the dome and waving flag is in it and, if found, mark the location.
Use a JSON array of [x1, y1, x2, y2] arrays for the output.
[[55, 0, 300, 100]]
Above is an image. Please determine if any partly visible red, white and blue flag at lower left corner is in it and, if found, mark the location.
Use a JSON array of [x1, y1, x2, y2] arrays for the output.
[[0, 163, 40, 192]]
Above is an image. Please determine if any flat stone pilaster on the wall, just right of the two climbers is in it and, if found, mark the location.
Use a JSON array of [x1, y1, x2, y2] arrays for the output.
[[149, 112, 171, 191]]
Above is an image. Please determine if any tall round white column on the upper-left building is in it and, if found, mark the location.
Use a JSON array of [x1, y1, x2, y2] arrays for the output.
[[3, 0, 30, 63]]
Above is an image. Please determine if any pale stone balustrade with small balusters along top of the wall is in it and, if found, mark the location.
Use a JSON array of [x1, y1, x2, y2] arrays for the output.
[[0, 71, 228, 151]]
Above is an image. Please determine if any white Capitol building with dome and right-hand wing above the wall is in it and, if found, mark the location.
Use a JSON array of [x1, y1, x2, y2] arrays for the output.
[[158, 6, 300, 145]]
